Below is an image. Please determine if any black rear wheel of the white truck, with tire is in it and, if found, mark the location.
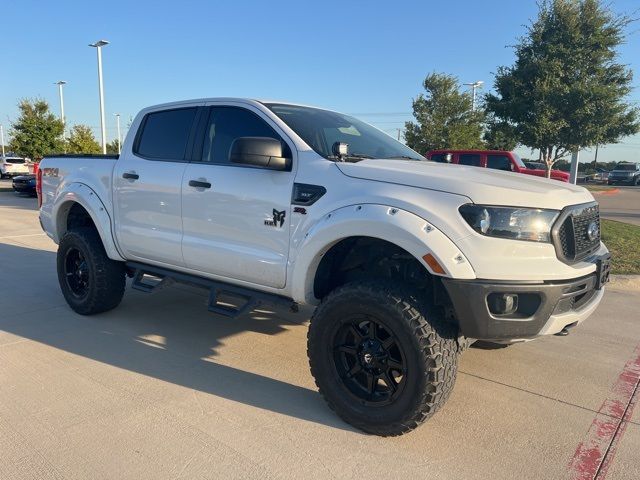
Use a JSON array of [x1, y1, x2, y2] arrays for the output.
[[57, 228, 126, 315]]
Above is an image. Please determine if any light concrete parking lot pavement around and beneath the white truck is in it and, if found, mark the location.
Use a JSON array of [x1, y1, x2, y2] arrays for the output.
[[0, 193, 640, 480]]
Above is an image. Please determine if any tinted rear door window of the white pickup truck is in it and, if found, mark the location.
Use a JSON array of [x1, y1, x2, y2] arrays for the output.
[[135, 108, 196, 160]]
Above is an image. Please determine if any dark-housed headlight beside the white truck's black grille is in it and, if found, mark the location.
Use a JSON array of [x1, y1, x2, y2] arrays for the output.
[[459, 204, 560, 242]]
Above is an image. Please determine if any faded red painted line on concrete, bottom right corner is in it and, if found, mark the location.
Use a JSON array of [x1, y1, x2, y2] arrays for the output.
[[569, 344, 640, 480]]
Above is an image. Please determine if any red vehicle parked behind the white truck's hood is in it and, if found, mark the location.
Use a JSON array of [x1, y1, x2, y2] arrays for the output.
[[427, 150, 569, 182]]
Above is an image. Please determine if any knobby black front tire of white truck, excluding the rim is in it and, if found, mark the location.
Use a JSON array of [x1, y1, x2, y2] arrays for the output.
[[307, 282, 459, 436]]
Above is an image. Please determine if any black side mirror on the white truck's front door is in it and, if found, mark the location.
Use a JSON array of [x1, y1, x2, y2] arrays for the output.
[[229, 137, 291, 170]]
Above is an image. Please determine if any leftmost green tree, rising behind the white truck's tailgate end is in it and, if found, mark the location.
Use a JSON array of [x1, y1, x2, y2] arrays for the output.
[[10, 98, 64, 160]]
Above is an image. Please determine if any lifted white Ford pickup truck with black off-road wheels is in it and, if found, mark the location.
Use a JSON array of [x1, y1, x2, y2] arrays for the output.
[[38, 98, 610, 435]]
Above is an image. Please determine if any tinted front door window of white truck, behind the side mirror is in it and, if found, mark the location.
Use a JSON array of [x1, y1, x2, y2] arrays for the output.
[[202, 107, 284, 163]]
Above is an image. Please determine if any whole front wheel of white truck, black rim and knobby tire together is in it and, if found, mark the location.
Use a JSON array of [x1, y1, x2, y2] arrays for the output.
[[307, 282, 459, 436]]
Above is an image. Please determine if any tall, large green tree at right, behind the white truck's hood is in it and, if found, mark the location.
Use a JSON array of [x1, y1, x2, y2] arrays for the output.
[[485, 0, 639, 176]]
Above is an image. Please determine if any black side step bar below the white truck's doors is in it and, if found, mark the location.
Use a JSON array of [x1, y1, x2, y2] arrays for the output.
[[126, 262, 298, 318]]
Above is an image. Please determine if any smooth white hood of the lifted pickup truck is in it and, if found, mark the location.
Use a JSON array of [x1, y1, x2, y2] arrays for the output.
[[336, 159, 593, 210]]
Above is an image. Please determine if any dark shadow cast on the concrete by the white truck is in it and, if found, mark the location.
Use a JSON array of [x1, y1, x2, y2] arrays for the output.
[[0, 243, 355, 431]]
